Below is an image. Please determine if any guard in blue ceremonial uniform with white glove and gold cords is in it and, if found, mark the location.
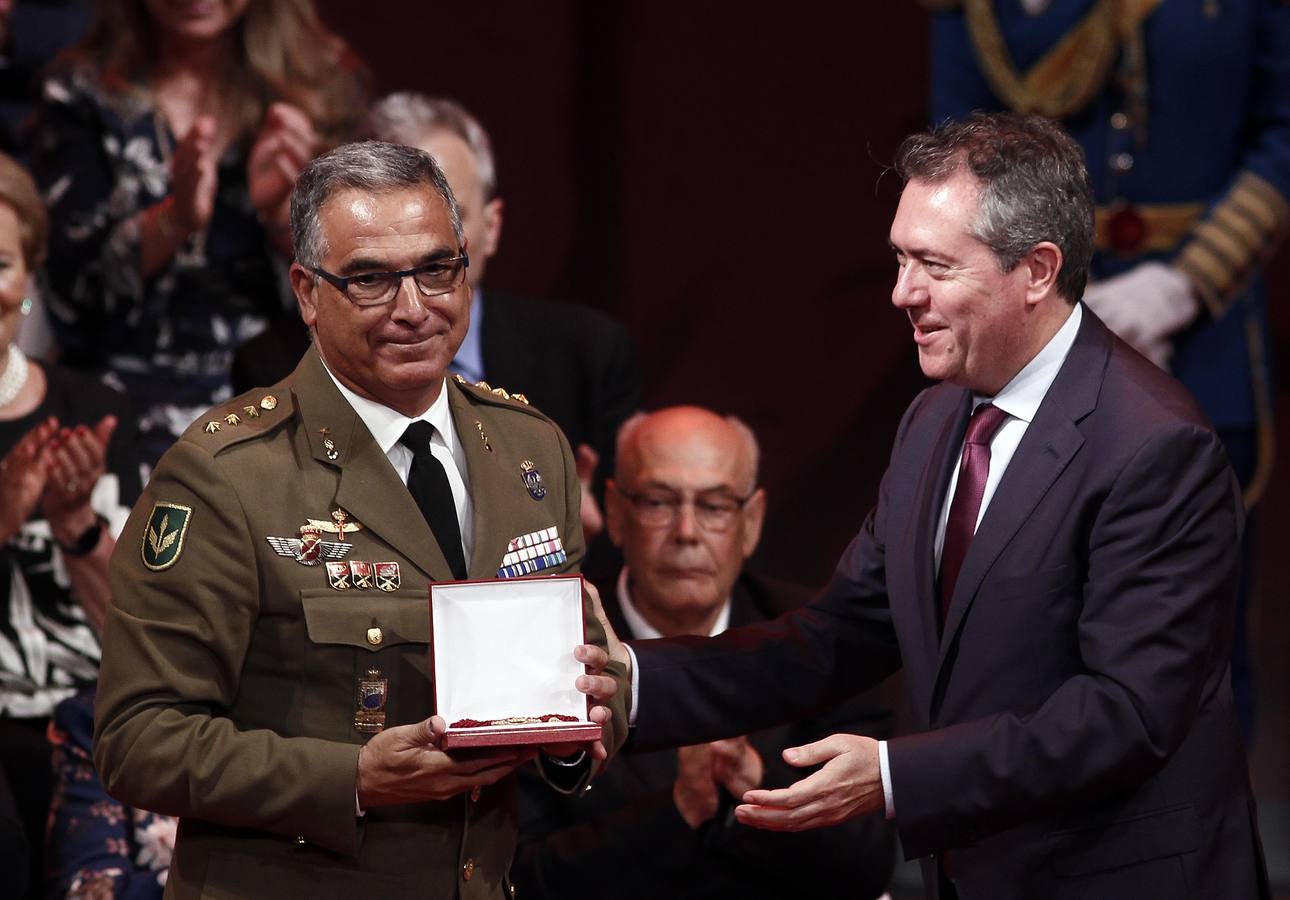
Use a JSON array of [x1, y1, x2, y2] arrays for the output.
[[928, 0, 1290, 739]]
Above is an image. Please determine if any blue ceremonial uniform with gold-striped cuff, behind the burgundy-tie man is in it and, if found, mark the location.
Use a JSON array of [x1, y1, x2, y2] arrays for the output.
[[931, 0, 1290, 469]]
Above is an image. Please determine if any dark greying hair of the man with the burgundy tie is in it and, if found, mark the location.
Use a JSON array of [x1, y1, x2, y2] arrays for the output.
[[895, 112, 1094, 303]]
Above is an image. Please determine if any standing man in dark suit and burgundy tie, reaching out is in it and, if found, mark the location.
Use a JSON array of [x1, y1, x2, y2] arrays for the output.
[[585, 115, 1268, 900]]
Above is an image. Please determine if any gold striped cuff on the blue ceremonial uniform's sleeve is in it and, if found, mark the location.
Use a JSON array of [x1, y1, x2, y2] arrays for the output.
[[1174, 171, 1290, 318]]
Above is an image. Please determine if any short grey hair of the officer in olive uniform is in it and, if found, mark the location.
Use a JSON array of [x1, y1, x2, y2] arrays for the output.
[[292, 141, 466, 267]]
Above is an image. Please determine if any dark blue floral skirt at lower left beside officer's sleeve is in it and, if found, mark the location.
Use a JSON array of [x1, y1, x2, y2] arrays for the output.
[[45, 691, 178, 900]]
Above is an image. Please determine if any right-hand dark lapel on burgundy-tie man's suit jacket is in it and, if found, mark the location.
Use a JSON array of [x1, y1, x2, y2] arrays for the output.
[[938, 312, 1111, 677]]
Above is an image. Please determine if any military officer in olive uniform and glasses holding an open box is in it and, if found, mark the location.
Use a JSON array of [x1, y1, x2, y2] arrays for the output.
[[94, 142, 626, 900]]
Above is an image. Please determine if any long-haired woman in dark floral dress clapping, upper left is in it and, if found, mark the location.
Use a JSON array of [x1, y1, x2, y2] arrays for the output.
[[34, 0, 364, 464]]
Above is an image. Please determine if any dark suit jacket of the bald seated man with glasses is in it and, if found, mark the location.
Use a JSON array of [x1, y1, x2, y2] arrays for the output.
[[512, 574, 895, 900]]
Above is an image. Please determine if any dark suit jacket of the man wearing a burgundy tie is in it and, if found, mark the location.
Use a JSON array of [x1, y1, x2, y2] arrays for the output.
[[635, 311, 1268, 900]]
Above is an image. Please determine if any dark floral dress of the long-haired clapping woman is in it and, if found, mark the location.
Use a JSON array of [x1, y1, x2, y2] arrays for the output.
[[32, 67, 294, 464]]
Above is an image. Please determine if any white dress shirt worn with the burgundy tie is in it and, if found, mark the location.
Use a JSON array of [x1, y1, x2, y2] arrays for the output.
[[878, 303, 1084, 819]]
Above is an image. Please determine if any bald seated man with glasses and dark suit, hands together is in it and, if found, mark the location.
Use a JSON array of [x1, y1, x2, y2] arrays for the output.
[[515, 406, 894, 900]]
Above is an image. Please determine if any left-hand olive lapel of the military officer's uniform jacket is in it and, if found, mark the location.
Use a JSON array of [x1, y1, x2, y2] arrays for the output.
[[292, 347, 453, 582]]
